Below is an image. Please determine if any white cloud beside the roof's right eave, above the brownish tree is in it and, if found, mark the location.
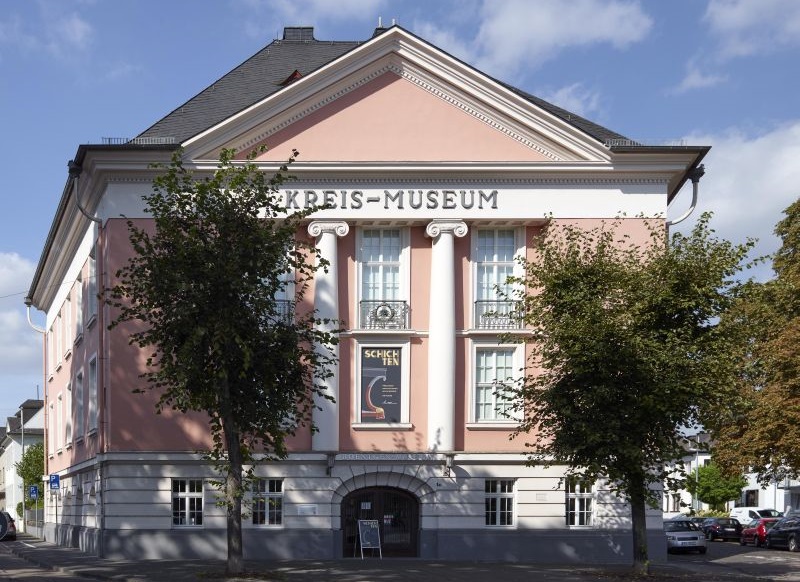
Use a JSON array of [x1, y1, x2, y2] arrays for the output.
[[670, 120, 800, 274]]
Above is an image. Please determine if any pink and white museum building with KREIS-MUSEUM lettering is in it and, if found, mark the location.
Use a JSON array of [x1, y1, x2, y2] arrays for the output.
[[27, 27, 708, 563]]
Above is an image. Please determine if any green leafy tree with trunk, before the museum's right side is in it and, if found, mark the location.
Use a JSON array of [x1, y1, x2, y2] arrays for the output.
[[506, 215, 750, 571]]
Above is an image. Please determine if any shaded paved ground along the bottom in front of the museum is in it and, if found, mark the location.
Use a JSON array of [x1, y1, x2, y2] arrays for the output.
[[0, 535, 765, 582]]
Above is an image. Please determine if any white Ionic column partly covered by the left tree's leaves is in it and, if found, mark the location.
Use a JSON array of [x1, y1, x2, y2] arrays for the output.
[[308, 220, 350, 451]]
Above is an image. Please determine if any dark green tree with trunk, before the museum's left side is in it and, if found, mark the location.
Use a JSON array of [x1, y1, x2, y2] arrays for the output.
[[106, 150, 337, 574]]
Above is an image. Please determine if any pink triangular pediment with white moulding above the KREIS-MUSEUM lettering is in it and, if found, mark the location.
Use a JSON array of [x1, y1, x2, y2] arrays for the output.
[[184, 28, 608, 164]]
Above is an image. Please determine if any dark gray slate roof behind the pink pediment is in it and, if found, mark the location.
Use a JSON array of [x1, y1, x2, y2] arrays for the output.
[[137, 27, 625, 144]]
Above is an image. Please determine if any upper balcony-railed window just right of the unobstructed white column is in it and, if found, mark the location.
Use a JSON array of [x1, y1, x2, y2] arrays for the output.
[[473, 228, 522, 329]]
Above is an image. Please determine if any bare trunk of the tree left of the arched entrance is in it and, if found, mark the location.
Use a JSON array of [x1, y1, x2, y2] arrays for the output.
[[221, 385, 244, 575]]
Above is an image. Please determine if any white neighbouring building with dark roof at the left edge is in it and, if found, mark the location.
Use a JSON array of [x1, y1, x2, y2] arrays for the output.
[[0, 400, 44, 531]]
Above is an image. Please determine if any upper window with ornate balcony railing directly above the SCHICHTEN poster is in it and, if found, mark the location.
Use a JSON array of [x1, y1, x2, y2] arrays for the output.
[[359, 228, 409, 329]]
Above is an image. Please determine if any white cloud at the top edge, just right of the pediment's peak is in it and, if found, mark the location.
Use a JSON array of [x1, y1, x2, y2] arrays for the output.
[[475, 0, 653, 77]]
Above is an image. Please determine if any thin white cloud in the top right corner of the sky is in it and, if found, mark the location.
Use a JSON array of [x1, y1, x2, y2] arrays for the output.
[[703, 0, 800, 58]]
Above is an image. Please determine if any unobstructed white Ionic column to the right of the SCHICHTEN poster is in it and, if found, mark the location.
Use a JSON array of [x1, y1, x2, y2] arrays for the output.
[[425, 220, 467, 451]]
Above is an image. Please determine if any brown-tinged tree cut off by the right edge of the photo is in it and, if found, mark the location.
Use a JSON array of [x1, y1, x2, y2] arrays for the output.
[[708, 200, 800, 485]]
